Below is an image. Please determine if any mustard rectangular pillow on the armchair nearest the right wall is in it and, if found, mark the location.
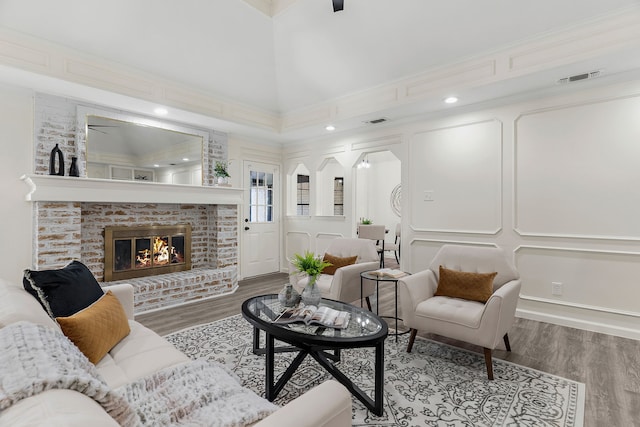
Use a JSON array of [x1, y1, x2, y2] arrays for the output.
[[434, 266, 498, 302]]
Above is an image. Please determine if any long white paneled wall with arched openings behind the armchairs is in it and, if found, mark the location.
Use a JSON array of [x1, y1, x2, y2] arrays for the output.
[[284, 81, 640, 339]]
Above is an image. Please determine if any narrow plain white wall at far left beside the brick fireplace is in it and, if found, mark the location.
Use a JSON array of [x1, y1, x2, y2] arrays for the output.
[[0, 84, 33, 283]]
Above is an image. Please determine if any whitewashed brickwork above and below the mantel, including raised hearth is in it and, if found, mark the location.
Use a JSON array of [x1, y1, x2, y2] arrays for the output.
[[33, 94, 238, 312]]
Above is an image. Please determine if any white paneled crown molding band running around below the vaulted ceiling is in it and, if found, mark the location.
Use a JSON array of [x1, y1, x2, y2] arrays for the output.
[[0, 7, 640, 138]]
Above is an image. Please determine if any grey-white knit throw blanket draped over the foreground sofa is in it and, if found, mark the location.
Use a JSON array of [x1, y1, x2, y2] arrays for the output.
[[0, 322, 278, 427]]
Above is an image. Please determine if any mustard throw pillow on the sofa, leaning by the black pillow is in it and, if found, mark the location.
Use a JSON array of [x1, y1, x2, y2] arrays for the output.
[[56, 291, 131, 364]]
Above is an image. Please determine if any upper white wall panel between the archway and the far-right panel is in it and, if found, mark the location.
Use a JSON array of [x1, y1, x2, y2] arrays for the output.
[[408, 120, 503, 234]]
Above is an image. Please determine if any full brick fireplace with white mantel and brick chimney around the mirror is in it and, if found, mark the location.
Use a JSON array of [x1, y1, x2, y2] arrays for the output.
[[23, 94, 243, 313]]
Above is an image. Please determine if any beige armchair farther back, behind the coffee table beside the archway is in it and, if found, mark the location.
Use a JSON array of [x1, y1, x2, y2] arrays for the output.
[[293, 238, 379, 310]]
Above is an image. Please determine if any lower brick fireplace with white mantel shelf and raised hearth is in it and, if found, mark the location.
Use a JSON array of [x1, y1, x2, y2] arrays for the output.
[[23, 175, 242, 313]]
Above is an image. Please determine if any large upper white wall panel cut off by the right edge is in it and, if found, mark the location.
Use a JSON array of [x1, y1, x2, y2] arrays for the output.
[[515, 96, 640, 240]]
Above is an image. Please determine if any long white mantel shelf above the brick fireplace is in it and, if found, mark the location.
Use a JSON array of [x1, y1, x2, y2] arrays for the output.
[[20, 175, 244, 205]]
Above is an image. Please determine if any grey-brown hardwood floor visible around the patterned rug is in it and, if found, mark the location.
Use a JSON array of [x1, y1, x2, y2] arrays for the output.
[[136, 266, 640, 427]]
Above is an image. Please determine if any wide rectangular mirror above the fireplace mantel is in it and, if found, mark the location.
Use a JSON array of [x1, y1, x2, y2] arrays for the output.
[[83, 111, 209, 186]]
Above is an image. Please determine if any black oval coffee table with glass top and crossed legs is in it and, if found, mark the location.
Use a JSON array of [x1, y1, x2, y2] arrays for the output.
[[242, 294, 388, 415]]
